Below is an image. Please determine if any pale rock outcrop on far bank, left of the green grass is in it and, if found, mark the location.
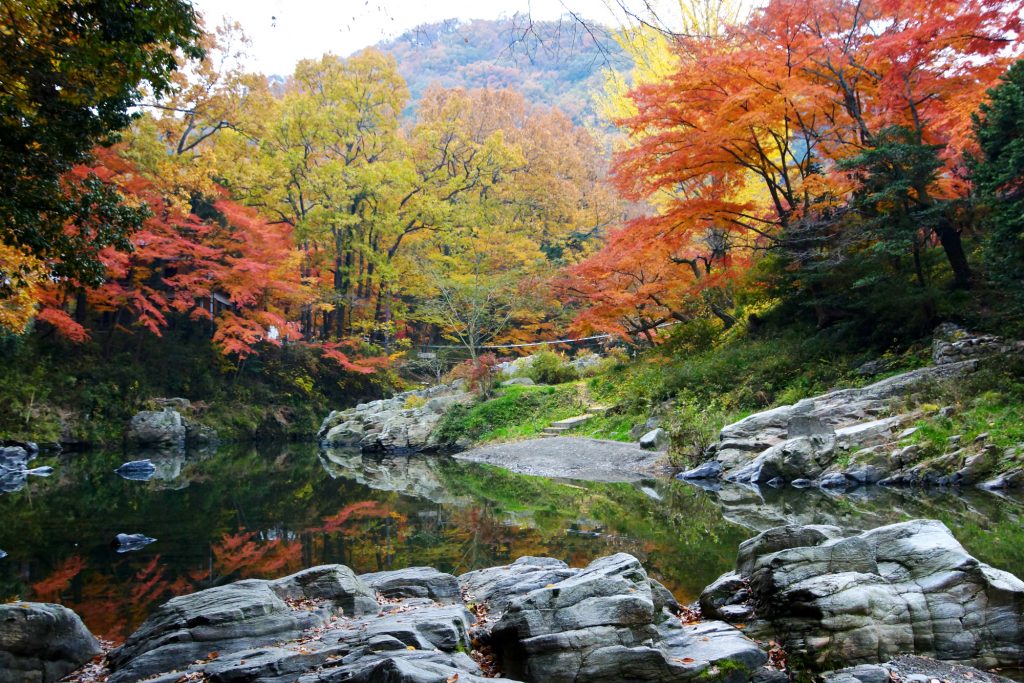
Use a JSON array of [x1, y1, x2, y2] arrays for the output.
[[316, 380, 473, 453]]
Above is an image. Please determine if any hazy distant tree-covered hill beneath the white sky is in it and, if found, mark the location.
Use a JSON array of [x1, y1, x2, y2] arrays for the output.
[[377, 15, 624, 123]]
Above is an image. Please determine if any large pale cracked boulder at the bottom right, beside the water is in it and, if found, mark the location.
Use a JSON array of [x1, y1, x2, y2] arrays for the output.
[[700, 520, 1024, 669]]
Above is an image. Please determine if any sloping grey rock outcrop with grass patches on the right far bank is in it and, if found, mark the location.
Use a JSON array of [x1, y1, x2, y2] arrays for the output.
[[679, 326, 1024, 489]]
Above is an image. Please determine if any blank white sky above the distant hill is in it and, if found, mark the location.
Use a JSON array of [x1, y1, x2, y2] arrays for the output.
[[193, 0, 614, 76]]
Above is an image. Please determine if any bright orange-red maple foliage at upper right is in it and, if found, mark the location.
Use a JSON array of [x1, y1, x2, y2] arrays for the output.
[[563, 0, 1024, 334]]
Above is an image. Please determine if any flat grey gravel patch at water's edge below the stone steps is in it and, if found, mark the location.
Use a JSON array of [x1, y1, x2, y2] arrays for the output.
[[456, 436, 663, 481]]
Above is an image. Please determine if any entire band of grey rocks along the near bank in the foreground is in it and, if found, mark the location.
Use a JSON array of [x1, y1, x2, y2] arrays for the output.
[[9, 520, 1024, 683]]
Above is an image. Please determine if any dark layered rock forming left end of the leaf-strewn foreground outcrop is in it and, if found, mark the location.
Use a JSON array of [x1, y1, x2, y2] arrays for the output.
[[108, 565, 378, 683]]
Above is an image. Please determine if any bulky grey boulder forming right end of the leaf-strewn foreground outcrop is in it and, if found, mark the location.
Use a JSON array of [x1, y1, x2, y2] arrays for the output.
[[483, 553, 767, 683]]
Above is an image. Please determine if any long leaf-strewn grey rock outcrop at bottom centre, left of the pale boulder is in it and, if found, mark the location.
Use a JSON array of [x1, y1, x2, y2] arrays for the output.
[[64, 554, 779, 683]]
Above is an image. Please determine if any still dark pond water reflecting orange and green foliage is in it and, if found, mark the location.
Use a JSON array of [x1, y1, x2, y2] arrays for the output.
[[0, 444, 1024, 641]]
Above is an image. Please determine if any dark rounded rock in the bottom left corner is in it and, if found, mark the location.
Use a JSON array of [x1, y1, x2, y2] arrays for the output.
[[0, 602, 100, 683]]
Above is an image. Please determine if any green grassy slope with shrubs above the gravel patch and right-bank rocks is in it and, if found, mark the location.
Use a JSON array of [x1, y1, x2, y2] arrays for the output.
[[442, 326, 928, 464]]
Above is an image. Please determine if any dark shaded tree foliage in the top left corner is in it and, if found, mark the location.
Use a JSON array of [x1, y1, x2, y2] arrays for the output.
[[0, 0, 202, 294]]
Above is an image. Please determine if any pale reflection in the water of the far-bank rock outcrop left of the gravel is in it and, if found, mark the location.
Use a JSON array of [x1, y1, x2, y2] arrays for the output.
[[321, 449, 467, 505]]
